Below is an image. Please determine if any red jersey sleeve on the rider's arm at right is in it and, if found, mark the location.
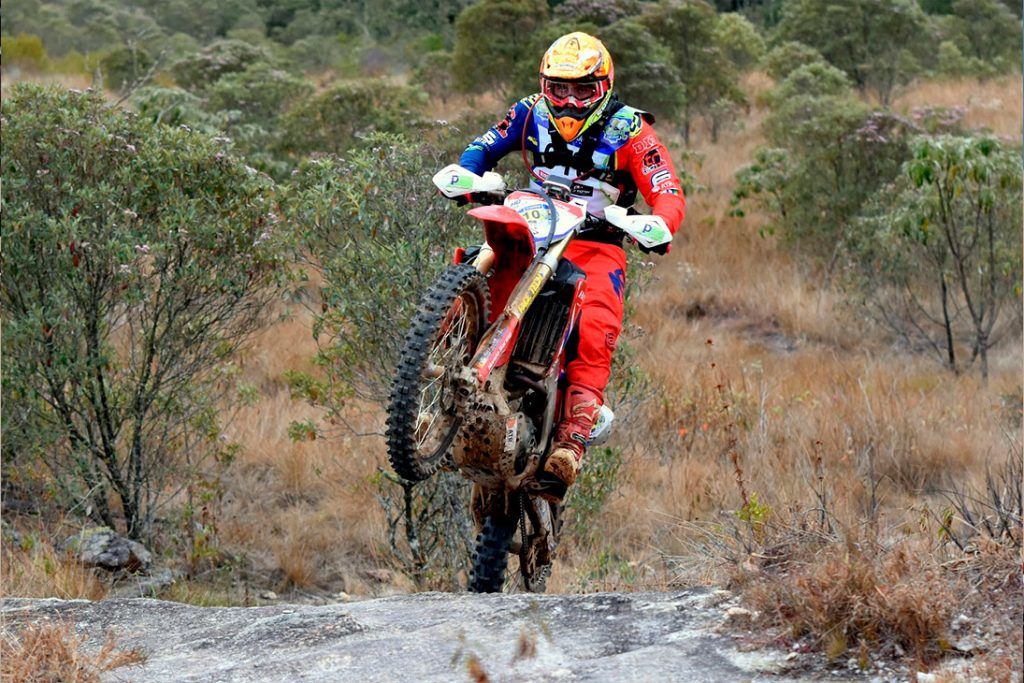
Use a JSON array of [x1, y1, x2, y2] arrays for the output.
[[618, 121, 686, 234]]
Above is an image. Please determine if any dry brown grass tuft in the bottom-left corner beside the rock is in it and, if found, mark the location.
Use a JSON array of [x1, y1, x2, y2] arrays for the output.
[[0, 623, 145, 683]]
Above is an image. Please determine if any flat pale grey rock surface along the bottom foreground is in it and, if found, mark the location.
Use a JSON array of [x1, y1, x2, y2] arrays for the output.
[[0, 590, 831, 682]]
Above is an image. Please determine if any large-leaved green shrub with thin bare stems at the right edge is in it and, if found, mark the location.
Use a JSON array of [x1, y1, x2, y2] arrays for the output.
[[850, 135, 1022, 377]]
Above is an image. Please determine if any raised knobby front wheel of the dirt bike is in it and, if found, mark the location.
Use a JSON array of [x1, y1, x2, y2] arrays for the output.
[[387, 264, 490, 481]]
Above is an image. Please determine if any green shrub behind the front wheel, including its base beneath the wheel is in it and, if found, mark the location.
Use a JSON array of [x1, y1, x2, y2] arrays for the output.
[[283, 131, 480, 590]]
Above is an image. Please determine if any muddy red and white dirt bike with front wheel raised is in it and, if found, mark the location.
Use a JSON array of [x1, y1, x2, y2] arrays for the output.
[[387, 165, 672, 593]]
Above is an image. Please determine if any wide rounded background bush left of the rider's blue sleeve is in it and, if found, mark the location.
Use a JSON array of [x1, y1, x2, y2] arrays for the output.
[[278, 80, 425, 159]]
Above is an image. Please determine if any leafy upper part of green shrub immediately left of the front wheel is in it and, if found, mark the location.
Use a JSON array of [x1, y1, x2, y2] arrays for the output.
[[282, 134, 478, 403]]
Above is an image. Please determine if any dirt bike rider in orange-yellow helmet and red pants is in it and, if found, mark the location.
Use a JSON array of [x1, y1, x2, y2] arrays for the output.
[[459, 32, 686, 499]]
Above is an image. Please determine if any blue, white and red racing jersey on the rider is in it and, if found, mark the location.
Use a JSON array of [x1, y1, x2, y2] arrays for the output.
[[459, 93, 686, 233]]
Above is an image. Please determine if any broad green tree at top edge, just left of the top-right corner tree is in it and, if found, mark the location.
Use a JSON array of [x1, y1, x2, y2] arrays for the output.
[[778, 0, 929, 104]]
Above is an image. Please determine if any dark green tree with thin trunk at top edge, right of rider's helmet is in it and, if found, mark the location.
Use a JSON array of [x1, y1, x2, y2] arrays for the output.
[[640, 0, 745, 143]]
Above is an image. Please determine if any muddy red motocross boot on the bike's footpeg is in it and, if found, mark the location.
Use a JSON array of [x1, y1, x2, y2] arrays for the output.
[[541, 385, 601, 503]]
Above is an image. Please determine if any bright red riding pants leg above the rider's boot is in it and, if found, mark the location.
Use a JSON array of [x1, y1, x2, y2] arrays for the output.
[[565, 240, 626, 402]]
